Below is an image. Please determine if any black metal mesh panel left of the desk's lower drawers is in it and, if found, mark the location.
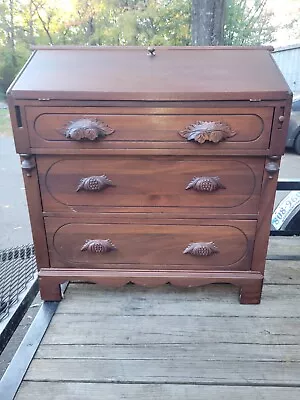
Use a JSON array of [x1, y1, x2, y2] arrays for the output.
[[0, 244, 37, 322]]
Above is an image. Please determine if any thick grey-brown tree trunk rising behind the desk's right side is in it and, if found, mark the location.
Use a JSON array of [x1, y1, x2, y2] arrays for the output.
[[192, 0, 226, 46]]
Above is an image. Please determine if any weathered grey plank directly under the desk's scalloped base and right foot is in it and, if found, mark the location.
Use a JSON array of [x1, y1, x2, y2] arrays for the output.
[[54, 284, 300, 321]]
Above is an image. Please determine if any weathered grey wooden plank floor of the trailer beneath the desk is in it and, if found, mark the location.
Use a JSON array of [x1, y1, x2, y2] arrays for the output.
[[16, 238, 300, 400]]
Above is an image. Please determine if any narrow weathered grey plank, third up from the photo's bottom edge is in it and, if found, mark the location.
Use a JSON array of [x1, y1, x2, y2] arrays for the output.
[[35, 343, 300, 362]]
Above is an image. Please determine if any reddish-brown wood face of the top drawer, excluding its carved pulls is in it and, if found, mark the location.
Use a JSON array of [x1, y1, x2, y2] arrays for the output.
[[26, 103, 273, 150]]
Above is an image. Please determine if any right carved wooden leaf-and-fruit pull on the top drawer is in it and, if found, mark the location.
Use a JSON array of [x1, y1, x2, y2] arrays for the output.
[[178, 121, 236, 144]]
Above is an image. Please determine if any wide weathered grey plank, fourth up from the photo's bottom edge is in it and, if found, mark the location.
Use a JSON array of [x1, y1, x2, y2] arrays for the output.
[[43, 314, 300, 345]]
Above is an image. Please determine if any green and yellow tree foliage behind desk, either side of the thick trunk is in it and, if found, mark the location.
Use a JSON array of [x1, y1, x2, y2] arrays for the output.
[[0, 0, 274, 90]]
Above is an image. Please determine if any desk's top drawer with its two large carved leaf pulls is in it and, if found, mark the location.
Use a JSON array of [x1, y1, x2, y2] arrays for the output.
[[26, 106, 273, 151]]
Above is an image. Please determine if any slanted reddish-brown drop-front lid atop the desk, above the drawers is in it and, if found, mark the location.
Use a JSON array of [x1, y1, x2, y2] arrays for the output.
[[8, 46, 290, 101]]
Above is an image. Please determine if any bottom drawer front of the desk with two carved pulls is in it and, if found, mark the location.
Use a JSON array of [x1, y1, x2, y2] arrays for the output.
[[45, 218, 256, 270]]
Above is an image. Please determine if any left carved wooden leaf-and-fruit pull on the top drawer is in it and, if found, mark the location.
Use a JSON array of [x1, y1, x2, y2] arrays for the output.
[[64, 118, 114, 140]]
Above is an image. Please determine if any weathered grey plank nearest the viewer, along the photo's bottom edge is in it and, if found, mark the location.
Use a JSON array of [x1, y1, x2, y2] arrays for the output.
[[16, 382, 300, 400]]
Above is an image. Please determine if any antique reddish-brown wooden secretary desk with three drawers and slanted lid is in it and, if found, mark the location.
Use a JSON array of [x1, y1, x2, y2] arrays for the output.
[[8, 47, 291, 303]]
